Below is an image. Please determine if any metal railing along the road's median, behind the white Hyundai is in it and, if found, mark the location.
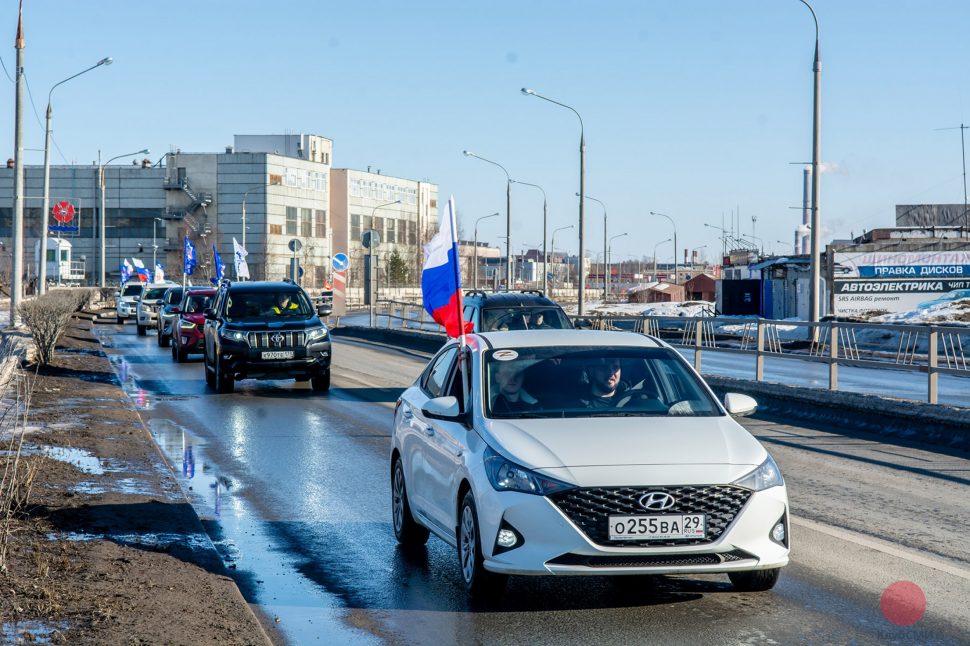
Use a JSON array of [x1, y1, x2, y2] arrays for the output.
[[364, 300, 970, 404]]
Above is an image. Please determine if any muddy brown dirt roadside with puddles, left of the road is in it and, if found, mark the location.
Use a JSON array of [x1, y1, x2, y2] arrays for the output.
[[0, 314, 281, 644]]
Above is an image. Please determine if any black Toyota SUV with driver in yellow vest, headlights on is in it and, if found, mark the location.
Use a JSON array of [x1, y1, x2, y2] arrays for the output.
[[204, 281, 331, 393]]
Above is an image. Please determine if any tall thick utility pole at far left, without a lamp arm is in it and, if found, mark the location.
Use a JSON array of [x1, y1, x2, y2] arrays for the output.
[[10, 0, 25, 327]]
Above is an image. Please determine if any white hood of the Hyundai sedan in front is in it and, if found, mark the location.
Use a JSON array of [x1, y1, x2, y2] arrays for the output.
[[483, 416, 766, 471]]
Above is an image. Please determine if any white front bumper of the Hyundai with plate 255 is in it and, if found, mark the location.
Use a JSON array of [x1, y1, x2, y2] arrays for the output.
[[475, 486, 790, 576]]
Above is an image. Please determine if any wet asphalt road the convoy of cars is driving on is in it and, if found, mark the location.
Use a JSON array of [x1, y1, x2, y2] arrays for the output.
[[98, 325, 970, 645]]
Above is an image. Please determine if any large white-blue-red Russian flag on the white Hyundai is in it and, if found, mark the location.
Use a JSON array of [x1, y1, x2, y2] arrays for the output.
[[421, 198, 472, 337]]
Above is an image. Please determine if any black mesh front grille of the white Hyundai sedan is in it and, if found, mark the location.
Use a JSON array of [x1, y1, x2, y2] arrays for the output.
[[549, 485, 751, 547]]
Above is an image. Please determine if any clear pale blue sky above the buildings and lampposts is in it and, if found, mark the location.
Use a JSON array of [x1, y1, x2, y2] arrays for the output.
[[0, 0, 970, 260]]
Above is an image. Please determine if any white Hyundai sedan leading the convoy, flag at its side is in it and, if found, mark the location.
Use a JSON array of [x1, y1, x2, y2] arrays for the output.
[[390, 330, 789, 596]]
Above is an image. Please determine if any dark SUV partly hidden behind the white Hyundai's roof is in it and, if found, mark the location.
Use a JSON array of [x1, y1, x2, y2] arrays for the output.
[[463, 289, 573, 332]]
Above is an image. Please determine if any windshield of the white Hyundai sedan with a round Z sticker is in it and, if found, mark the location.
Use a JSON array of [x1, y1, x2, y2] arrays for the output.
[[483, 346, 721, 418]]
